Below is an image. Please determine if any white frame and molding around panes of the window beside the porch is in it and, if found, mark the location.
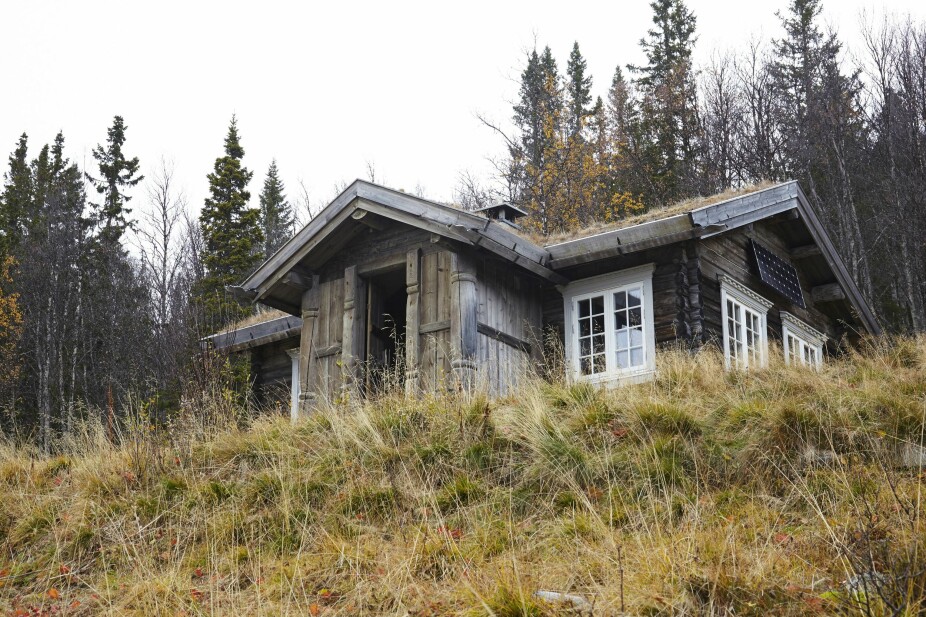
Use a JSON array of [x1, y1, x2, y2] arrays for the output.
[[560, 263, 656, 385]]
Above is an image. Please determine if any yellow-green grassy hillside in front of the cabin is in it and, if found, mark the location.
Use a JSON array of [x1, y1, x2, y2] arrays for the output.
[[0, 339, 926, 617]]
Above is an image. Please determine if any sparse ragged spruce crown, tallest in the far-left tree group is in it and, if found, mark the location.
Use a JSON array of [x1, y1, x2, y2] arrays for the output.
[[87, 116, 144, 247]]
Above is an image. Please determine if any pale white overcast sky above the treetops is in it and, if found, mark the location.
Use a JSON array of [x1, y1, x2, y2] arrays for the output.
[[0, 0, 926, 224]]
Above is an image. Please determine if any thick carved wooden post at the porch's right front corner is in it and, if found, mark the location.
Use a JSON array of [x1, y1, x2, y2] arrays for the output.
[[450, 253, 477, 390]]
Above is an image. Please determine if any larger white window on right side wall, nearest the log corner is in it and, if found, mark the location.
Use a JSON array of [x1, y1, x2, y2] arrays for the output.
[[720, 275, 772, 369]]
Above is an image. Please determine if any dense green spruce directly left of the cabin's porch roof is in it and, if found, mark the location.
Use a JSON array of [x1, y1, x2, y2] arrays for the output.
[[197, 116, 263, 326]]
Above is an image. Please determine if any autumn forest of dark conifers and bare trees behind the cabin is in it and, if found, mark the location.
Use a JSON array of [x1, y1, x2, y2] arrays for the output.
[[0, 0, 926, 448]]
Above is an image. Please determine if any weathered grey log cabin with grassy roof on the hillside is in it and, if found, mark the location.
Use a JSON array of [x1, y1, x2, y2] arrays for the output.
[[207, 180, 880, 416]]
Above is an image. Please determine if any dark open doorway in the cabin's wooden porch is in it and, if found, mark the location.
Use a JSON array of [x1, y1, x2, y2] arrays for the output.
[[364, 268, 407, 395]]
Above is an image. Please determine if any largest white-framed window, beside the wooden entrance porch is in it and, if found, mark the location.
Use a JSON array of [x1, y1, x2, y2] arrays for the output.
[[563, 264, 656, 382]]
